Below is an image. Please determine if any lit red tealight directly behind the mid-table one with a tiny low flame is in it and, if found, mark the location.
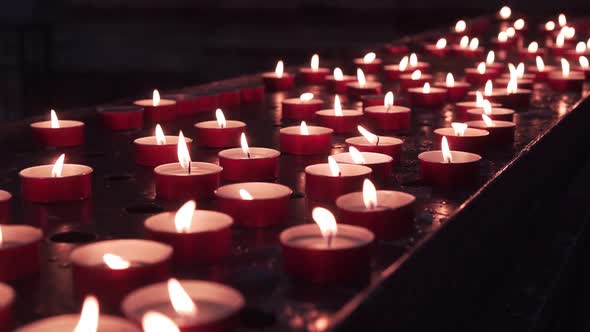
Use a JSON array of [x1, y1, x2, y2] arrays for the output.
[[218, 133, 281, 182]]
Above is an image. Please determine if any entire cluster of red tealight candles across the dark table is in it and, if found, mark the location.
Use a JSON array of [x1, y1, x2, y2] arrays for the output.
[[0, 7, 590, 332]]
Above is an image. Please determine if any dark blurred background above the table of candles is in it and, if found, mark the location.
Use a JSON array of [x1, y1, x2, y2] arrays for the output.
[[0, 0, 590, 119]]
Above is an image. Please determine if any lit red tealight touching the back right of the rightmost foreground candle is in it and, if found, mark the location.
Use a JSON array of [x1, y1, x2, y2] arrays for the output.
[[336, 179, 416, 240]]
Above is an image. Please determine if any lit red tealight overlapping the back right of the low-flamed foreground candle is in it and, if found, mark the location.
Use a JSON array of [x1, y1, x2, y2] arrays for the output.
[[144, 201, 233, 265]]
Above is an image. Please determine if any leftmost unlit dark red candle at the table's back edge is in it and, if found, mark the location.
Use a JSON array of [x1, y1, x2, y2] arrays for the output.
[[97, 105, 143, 130]]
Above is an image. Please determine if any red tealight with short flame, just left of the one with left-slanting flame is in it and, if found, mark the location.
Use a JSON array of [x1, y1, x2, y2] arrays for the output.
[[280, 121, 334, 155]]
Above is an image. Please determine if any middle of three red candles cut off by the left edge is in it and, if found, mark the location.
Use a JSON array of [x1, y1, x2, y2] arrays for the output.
[[0, 225, 43, 282]]
